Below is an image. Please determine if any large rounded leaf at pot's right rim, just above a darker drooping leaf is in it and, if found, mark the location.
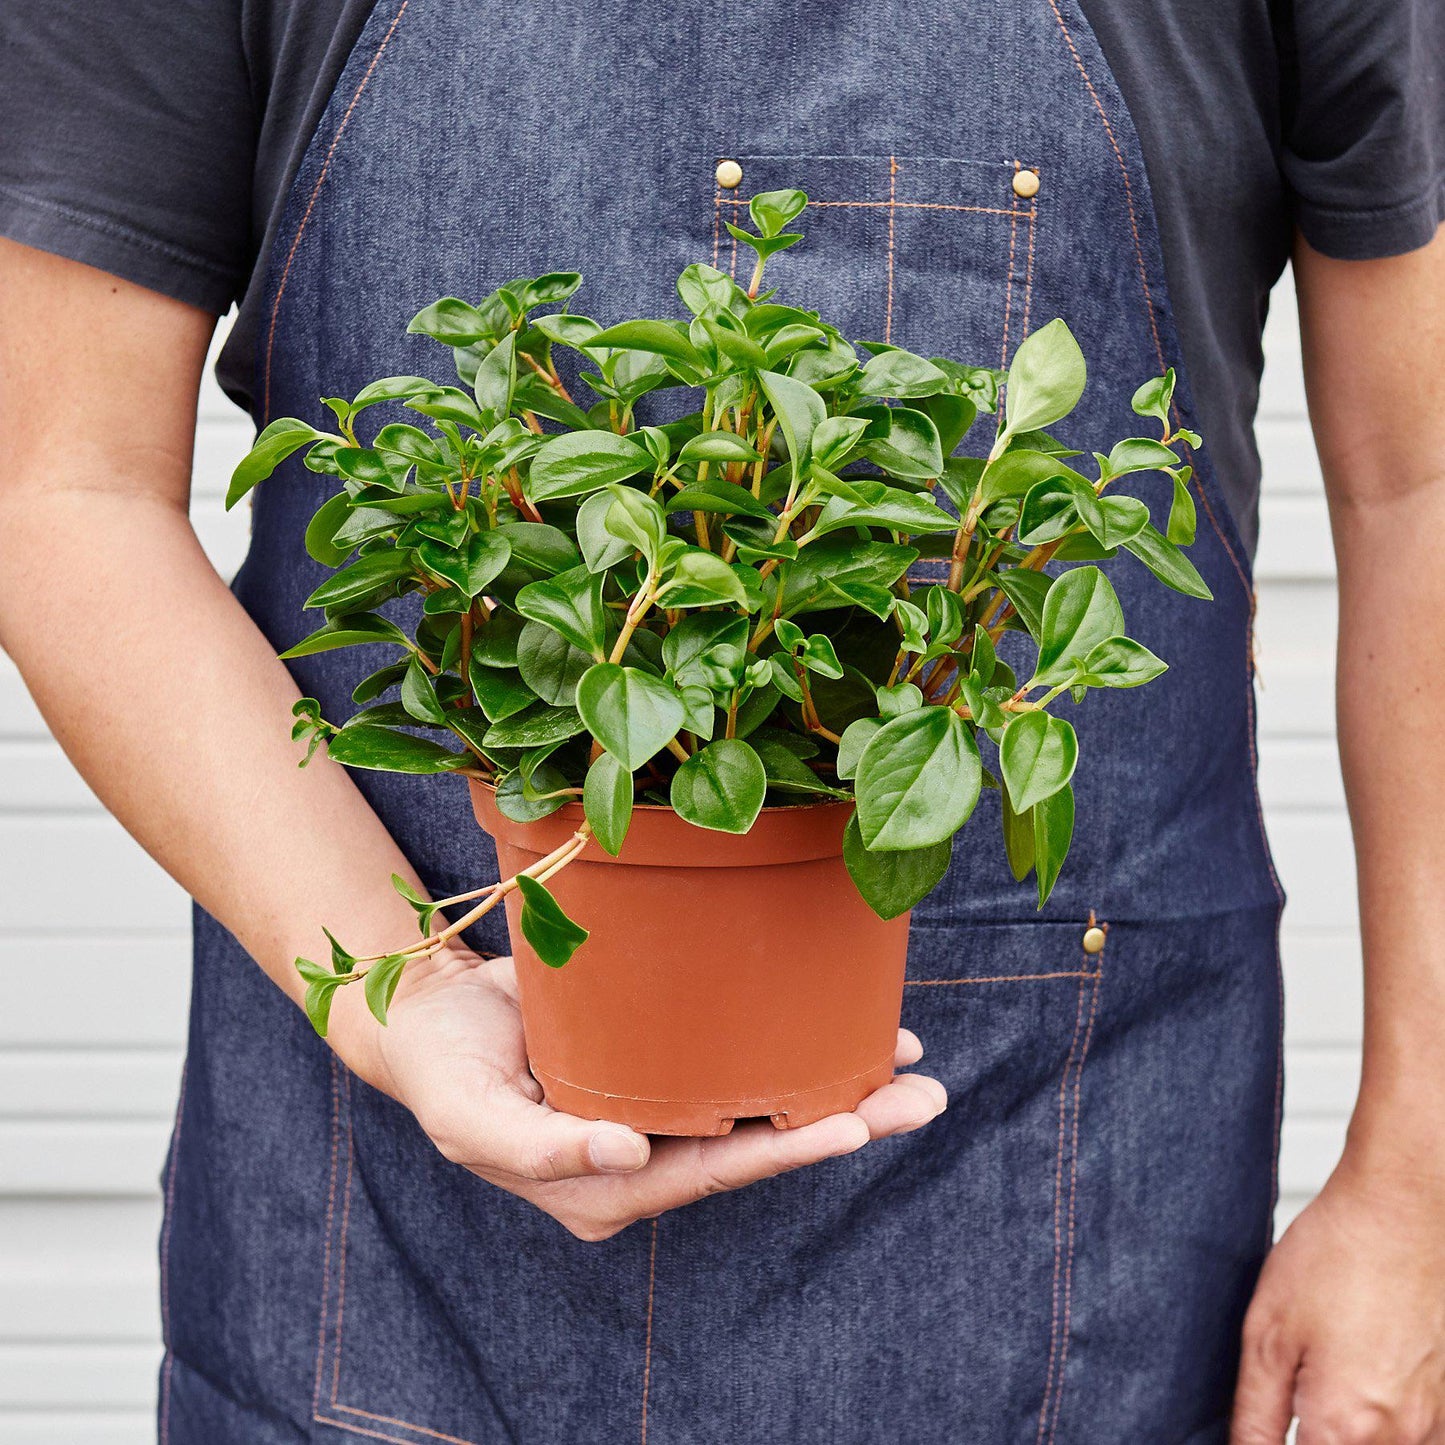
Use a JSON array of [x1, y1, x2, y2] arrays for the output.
[[854, 707, 983, 853]]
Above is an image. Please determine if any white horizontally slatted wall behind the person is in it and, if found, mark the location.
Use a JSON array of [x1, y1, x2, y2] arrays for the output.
[[0, 275, 1360, 1445]]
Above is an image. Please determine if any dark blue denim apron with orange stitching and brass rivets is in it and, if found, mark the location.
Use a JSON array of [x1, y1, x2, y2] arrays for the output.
[[160, 0, 1282, 1445]]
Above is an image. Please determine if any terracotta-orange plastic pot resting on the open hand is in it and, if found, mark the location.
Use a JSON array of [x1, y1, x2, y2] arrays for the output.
[[471, 782, 909, 1134]]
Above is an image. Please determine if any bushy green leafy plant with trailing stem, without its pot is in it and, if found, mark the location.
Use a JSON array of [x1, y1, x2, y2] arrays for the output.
[[227, 191, 1209, 1032]]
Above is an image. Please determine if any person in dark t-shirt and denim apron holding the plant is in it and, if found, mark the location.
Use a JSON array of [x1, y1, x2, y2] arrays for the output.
[[0, 0, 1445, 1445]]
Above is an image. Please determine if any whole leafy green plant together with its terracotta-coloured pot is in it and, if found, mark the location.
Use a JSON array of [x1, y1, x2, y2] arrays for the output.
[[228, 191, 1209, 1134]]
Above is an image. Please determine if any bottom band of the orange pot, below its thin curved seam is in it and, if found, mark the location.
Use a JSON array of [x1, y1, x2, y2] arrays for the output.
[[532, 1058, 893, 1139]]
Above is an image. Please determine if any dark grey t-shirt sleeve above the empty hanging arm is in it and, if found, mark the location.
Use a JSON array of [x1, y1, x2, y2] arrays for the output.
[[1282, 0, 1445, 260]]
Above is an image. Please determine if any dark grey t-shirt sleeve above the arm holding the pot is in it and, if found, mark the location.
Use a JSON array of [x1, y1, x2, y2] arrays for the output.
[[0, 0, 256, 314]]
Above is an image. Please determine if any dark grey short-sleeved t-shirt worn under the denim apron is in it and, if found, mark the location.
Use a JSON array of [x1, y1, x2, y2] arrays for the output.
[[0, 0, 1445, 548]]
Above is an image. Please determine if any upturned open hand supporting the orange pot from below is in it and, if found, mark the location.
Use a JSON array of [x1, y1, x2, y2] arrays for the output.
[[331, 949, 948, 1241]]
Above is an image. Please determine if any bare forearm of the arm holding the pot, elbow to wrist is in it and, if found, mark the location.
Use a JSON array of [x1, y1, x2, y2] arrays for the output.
[[0, 491, 433, 1069]]
